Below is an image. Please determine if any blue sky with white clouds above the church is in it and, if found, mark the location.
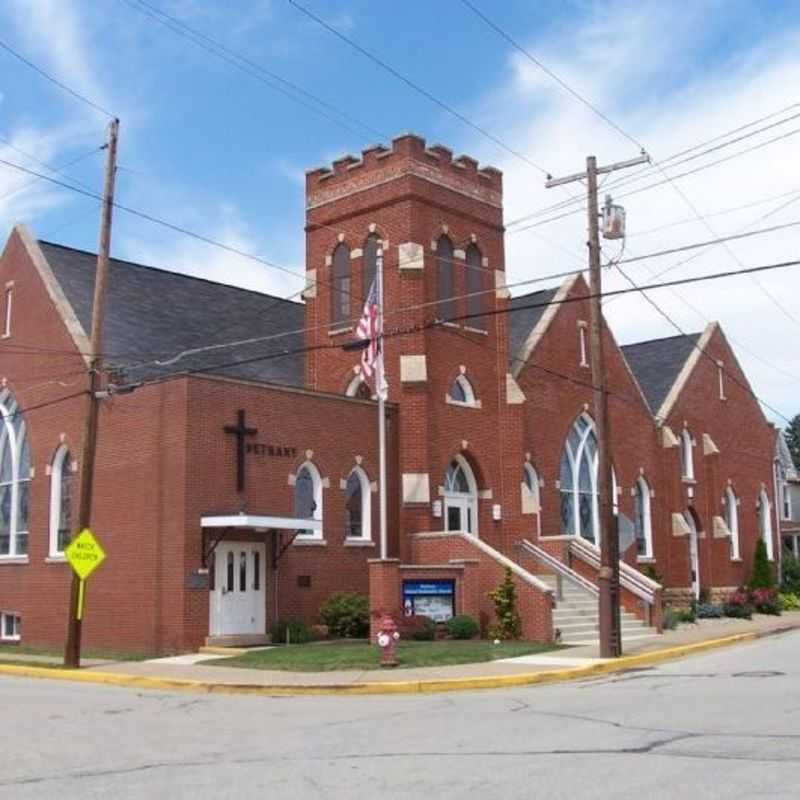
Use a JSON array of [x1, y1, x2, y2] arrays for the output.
[[0, 0, 800, 422]]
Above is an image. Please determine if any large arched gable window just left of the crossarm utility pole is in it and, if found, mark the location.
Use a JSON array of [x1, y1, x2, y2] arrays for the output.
[[560, 414, 598, 543]]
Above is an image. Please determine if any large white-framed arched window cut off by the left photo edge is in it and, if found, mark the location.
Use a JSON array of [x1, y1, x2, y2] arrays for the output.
[[0, 389, 31, 557]]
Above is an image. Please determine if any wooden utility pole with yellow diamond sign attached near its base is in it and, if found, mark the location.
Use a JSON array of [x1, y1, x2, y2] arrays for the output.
[[64, 119, 119, 669]]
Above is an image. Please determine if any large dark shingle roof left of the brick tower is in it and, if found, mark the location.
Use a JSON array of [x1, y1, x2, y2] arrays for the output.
[[39, 241, 305, 386]]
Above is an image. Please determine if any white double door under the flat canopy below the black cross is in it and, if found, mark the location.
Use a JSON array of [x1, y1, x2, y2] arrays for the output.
[[209, 542, 266, 636]]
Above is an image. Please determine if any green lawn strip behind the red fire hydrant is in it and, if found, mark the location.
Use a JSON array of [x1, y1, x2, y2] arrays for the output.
[[209, 639, 560, 672]]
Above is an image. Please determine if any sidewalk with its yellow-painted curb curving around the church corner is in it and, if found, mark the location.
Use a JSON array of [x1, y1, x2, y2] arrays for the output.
[[0, 612, 800, 695]]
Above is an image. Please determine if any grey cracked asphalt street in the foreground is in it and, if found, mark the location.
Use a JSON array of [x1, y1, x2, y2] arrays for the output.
[[0, 632, 800, 800]]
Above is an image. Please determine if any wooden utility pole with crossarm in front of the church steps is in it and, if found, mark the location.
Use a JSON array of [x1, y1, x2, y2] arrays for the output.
[[545, 153, 650, 658]]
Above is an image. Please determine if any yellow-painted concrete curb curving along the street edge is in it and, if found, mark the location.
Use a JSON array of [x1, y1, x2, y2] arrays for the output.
[[0, 626, 797, 697]]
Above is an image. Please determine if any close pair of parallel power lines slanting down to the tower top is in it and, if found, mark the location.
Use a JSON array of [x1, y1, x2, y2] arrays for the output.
[[122, 0, 389, 139]]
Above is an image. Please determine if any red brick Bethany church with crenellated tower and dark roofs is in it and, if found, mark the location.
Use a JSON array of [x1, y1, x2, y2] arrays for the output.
[[0, 135, 778, 653]]
